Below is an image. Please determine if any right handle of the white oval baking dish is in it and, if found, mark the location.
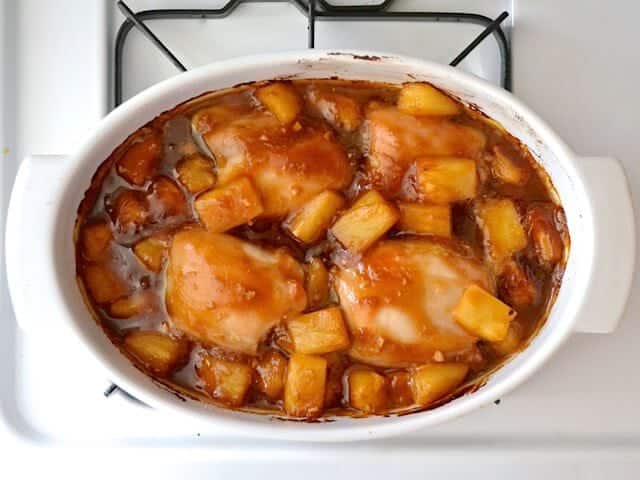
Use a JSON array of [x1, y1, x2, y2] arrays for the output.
[[575, 157, 636, 333]]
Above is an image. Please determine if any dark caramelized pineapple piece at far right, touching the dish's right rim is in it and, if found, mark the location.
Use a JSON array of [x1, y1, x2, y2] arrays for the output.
[[527, 205, 564, 268]]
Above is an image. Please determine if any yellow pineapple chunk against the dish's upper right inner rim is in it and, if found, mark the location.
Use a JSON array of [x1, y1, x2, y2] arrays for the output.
[[398, 83, 460, 116]]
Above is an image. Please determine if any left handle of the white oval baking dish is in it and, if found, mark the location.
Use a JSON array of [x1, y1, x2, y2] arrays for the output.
[[5, 155, 73, 332]]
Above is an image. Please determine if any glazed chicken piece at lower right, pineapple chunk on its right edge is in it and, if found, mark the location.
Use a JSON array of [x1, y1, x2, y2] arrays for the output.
[[335, 240, 493, 367]]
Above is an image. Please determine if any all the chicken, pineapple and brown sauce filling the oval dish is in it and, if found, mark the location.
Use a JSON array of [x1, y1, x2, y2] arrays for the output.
[[75, 80, 569, 419]]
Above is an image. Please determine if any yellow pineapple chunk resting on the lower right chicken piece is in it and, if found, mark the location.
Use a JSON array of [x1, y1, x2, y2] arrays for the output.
[[452, 285, 516, 342]]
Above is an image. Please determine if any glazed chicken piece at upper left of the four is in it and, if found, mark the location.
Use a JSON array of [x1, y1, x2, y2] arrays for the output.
[[198, 106, 353, 218]]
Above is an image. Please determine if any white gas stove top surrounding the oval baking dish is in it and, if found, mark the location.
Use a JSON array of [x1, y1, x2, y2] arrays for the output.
[[0, 0, 640, 478]]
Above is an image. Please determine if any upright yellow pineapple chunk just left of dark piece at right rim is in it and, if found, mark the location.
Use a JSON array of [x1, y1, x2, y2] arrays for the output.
[[476, 198, 527, 262]]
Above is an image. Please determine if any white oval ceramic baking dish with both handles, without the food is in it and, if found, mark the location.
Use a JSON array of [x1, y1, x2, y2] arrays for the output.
[[5, 50, 635, 442]]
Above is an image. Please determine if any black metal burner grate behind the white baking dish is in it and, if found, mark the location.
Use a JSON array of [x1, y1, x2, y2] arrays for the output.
[[104, 0, 511, 398]]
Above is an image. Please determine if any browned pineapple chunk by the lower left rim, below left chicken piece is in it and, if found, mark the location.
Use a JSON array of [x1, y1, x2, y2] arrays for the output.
[[124, 330, 189, 376]]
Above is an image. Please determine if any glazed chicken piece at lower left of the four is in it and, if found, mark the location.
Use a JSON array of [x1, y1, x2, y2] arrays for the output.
[[166, 229, 307, 355]]
